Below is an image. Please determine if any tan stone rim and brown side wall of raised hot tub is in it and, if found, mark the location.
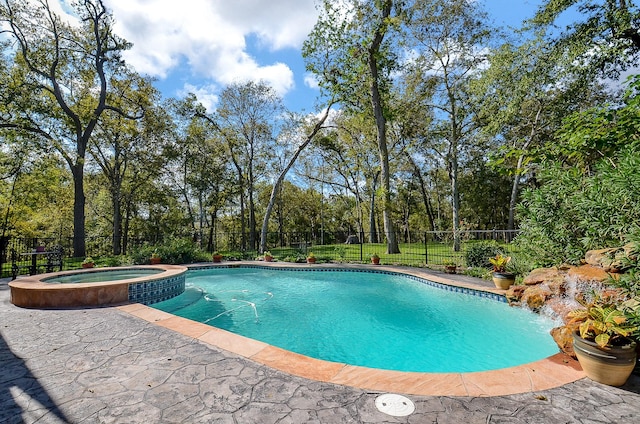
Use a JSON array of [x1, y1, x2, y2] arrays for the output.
[[9, 265, 187, 308]]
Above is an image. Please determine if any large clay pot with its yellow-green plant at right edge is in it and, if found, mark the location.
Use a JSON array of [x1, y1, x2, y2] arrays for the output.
[[567, 297, 640, 386]]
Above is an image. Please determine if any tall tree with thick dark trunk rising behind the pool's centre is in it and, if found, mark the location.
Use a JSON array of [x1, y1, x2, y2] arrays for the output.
[[303, 0, 400, 253]]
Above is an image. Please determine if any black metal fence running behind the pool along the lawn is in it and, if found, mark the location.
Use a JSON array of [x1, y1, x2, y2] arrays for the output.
[[0, 230, 517, 277]]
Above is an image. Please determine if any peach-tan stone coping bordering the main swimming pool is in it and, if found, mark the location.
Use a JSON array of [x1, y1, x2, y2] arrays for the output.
[[116, 261, 585, 397]]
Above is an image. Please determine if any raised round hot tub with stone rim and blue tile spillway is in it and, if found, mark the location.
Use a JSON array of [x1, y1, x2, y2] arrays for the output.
[[9, 265, 187, 308]]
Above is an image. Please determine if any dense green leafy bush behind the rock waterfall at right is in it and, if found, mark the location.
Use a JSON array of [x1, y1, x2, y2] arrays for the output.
[[516, 149, 640, 265]]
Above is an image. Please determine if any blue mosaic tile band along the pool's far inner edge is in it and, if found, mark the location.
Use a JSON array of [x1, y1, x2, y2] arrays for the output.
[[189, 264, 507, 303]]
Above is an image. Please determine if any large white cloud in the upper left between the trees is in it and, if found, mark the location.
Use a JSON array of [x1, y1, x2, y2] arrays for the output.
[[105, 0, 317, 95]]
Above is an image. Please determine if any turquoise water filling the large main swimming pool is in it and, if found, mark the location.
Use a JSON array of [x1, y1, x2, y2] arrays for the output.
[[152, 268, 558, 372]]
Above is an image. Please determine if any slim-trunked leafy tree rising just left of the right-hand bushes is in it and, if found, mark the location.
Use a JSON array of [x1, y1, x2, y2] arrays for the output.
[[471, 38, 606, 230]]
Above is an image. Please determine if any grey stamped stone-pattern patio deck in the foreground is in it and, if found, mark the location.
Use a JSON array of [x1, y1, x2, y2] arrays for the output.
[[0, 266, 640, 424]]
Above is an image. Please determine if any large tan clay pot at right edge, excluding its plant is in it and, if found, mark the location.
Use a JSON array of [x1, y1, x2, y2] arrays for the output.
[[573, 333, 637, 386]]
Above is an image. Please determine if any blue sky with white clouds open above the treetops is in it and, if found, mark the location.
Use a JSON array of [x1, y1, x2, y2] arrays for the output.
[[95, 0, 552, 112]]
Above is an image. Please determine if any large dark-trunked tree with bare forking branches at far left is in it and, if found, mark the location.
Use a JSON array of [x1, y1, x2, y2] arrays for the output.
[[0, 0, 141, 256]]
